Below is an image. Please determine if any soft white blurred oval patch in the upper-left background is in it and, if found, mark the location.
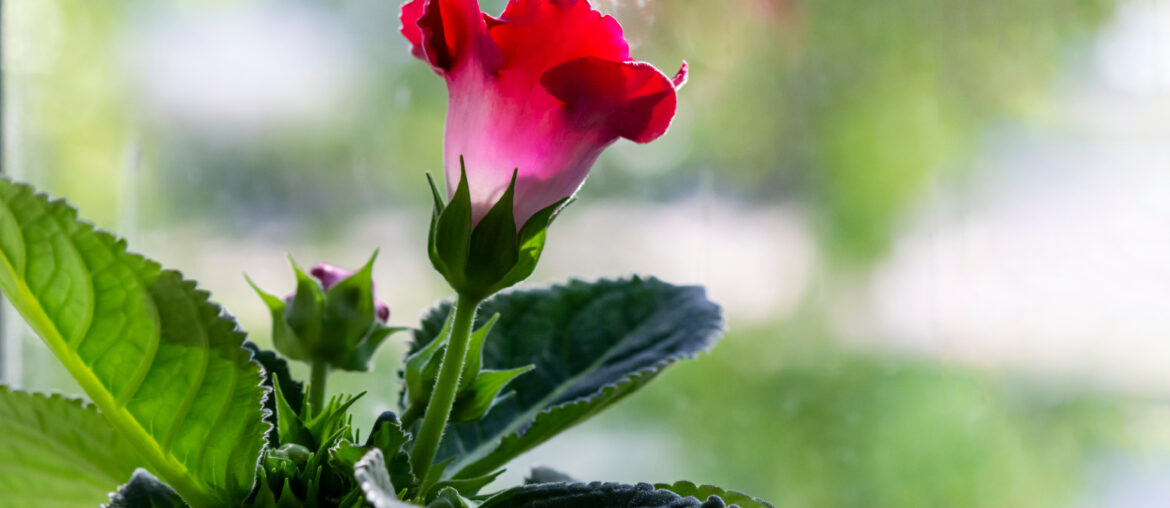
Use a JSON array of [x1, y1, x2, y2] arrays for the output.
[[123, 2, 362, 136]]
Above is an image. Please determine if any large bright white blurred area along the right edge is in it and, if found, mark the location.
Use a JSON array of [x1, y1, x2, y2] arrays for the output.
[[853, 0, 1170, 397]]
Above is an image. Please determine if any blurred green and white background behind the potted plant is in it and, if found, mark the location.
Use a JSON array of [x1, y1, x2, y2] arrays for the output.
[[0, 0, 1170, 507]]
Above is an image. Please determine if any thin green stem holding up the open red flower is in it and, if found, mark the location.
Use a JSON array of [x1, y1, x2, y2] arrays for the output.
[[411, 296, 480, 478]]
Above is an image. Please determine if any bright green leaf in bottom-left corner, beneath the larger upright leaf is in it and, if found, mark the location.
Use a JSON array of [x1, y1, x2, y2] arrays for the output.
[[0, 385, 143, 508]]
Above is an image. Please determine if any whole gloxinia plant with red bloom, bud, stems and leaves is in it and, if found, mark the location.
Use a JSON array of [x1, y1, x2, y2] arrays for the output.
[[0, 0, 769, 508]]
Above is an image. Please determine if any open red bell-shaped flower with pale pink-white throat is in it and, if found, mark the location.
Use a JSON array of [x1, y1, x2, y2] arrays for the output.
[[401, 0, 687, 227]]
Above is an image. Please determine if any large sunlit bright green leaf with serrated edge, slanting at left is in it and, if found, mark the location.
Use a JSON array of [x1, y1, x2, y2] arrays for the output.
[[0, 179, 268, 507]]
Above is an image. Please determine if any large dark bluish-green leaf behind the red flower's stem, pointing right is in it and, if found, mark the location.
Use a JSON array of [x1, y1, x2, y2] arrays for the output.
[[412, 277, 723, 478]]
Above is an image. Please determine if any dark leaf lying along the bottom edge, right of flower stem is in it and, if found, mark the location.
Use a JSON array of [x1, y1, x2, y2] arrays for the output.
[[480, 482, 727, 508]]
